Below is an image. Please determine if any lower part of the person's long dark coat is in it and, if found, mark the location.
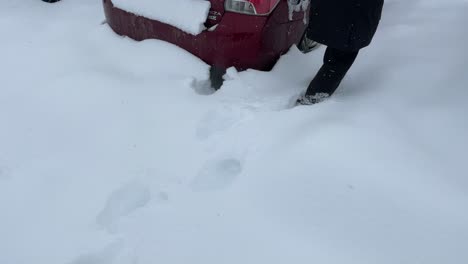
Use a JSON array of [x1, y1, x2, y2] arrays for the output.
[[307, 0, 384, 51]]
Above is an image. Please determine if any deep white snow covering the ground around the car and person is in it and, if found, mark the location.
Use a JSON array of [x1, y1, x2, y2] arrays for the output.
[[0, 0, 468, 264]]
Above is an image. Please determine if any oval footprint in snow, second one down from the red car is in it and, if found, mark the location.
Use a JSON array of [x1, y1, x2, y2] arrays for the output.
[[190, 159, 242, 191]]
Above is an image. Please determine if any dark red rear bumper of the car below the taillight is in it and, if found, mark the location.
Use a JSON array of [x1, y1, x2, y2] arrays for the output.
[[103, 0, 305, 70]]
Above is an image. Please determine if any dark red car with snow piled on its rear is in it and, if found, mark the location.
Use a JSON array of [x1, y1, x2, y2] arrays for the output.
[[103, 0, 314, 86]]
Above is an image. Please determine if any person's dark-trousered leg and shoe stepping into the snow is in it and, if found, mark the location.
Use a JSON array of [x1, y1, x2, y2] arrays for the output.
[[298, 47, 359, 104]]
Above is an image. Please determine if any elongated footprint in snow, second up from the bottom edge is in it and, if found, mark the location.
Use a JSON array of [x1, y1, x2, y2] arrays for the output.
[[96, 182, 151, 227]]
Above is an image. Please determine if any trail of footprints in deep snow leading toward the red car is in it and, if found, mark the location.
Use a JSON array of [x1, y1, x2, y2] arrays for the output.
[[67, 104, 247, 264]]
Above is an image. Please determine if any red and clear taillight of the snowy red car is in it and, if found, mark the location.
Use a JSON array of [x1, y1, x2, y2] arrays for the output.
[[224, 0, 280, 16]]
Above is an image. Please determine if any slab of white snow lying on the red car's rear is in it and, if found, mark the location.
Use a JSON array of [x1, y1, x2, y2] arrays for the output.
[[112, 0, 211, 35]]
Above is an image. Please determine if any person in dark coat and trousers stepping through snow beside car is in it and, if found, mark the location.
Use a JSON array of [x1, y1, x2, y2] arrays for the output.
[[297, 0, 384, 105]]
